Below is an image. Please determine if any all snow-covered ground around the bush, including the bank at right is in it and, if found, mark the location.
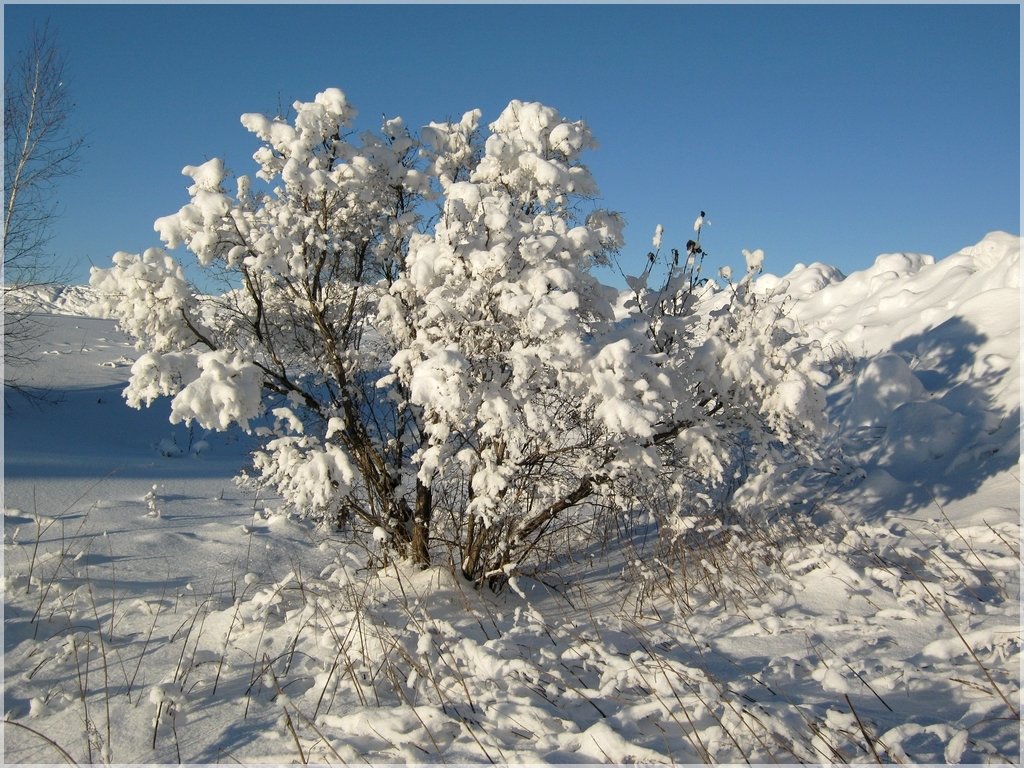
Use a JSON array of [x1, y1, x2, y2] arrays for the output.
[[4, 233, 1021, 763]]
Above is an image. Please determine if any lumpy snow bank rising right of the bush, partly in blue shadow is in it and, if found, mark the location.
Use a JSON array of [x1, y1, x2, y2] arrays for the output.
[[770, 232, 1020, 524]]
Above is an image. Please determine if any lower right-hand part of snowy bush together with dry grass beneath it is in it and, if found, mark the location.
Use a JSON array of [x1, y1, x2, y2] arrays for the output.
[[598, 225, 836, 599]]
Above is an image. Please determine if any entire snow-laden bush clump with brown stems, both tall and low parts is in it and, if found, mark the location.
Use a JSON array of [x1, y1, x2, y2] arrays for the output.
[[92, 89, 825, 582]]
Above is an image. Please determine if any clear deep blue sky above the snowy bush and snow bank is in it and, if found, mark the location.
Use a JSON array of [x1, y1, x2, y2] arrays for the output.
[[4, 4, 1021, 290]]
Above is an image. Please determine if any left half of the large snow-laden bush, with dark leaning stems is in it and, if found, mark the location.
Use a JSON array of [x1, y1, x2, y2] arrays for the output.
[[92, 89, 429, 565]]
